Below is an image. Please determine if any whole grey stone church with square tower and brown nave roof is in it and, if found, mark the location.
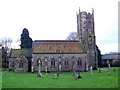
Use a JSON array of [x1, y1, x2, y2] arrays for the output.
[[9, 9, 98, 72]]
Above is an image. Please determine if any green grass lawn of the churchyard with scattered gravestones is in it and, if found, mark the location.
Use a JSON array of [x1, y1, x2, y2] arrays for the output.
[[2, 68, 118, 88]]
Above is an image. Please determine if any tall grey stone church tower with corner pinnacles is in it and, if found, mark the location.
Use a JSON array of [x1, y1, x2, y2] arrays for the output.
[[77, 8, 97, 67]]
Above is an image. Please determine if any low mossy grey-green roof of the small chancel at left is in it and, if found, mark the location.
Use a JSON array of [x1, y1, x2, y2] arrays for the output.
[[10, 49, 32, 58]]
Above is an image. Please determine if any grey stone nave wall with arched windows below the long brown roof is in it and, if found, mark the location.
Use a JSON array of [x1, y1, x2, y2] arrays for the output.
[[32, 54, 87, 71]]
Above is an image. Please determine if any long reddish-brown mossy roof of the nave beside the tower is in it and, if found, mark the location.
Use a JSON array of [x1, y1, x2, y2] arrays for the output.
[[33, 40, 84, 54]]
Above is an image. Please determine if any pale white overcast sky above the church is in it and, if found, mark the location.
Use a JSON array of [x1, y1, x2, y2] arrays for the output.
[[0, 0, 119, 54]]
